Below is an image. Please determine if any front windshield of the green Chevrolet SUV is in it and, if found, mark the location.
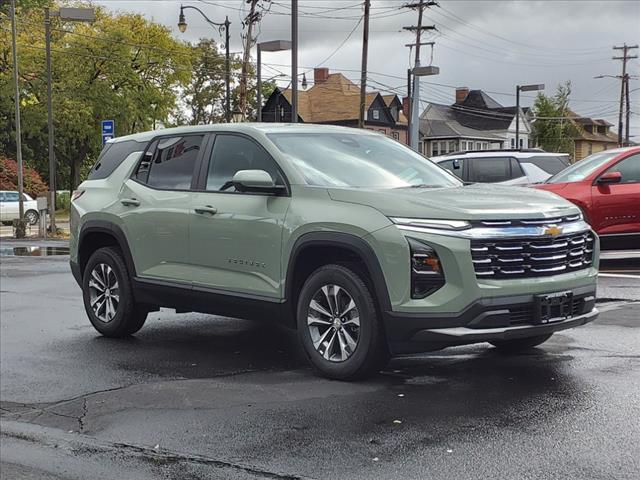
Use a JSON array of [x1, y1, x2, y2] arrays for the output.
[[269, 133, 462, 188]]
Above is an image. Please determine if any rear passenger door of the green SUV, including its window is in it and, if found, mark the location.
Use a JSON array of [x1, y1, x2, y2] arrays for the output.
[[116, 134, 206, 284]]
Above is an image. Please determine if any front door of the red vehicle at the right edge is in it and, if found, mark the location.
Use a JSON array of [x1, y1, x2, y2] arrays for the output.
[[591, 153, 640, 235]]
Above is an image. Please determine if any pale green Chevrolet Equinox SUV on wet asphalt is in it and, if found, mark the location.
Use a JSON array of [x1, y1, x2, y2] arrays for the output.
[[71, 123, 599, 379]]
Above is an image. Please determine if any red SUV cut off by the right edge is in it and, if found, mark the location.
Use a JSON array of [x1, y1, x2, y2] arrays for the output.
[[535, 147, 640, 248]]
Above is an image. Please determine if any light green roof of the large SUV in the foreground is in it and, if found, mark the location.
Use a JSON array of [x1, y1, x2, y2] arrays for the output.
[[108, 122, 378, 143]]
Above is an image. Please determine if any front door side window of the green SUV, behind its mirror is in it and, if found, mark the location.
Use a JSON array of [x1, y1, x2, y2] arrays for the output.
[[206, 135, 284, 190]]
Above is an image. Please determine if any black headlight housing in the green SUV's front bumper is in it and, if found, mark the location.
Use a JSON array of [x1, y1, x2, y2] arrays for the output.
[[407, 237, 445, 299]]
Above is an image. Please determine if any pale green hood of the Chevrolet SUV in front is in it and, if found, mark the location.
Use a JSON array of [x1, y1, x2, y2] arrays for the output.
[[329, 183, 579, 220]]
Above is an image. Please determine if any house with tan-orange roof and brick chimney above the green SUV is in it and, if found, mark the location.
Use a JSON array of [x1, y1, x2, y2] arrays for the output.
[[261, 68, 407, 144]]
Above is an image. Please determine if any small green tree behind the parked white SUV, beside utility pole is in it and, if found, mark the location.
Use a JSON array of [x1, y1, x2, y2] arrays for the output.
[[532, 81, 581, 157]]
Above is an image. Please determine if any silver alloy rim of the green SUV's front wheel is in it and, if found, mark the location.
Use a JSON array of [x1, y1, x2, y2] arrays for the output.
[[307, 284, 360, 362]]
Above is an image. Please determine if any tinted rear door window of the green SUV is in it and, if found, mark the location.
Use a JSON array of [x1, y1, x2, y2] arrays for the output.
[[144, 135, 204, 190]]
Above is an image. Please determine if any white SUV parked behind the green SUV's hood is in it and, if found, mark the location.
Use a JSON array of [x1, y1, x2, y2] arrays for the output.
[[430, 148, 569, 185]]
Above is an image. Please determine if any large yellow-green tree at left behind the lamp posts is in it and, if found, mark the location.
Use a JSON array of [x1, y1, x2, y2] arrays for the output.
[[0, 1, 192, 189]]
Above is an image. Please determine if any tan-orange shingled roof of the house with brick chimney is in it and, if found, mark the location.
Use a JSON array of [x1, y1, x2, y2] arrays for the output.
[[279, 73, 406, 123]]
